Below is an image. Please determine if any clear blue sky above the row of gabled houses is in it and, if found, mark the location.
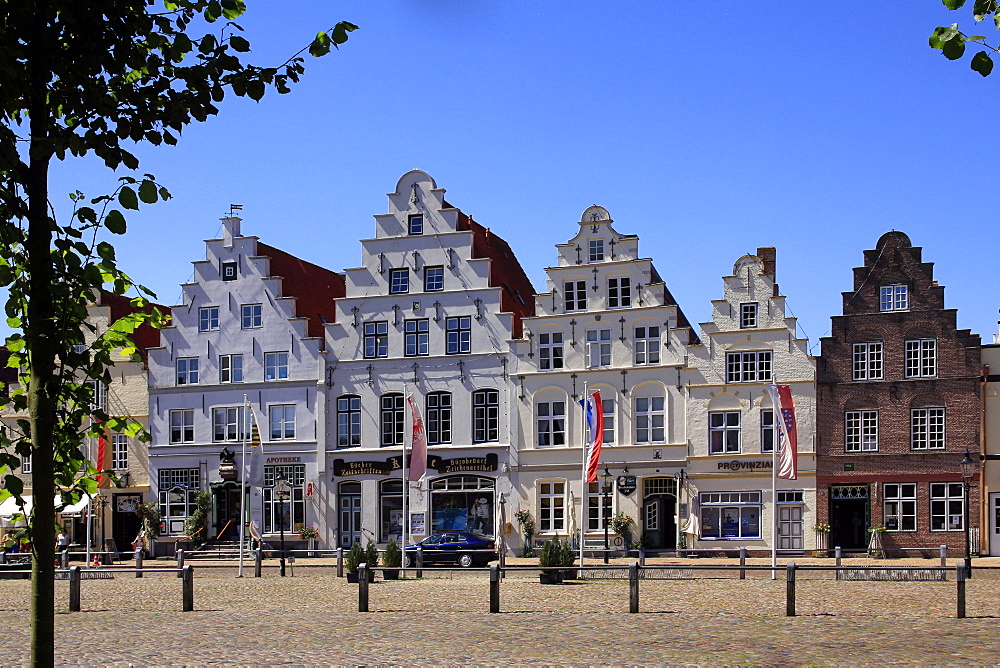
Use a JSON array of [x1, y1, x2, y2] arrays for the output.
[[43, 0, 1000, 353]]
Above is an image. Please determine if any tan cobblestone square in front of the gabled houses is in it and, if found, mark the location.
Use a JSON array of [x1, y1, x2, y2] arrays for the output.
[[0, 559, 1000, 666]]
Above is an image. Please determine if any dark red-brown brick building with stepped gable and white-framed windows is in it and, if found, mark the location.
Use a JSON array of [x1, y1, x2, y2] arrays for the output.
[[817, 232, 981, 554]]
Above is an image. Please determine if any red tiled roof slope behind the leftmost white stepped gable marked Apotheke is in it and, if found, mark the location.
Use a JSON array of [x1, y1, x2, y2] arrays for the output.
[[257, 241, 346, 338]]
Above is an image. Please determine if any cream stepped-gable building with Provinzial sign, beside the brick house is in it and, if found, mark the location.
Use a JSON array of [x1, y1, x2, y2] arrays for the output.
[[684, 248, 816, 551]]
